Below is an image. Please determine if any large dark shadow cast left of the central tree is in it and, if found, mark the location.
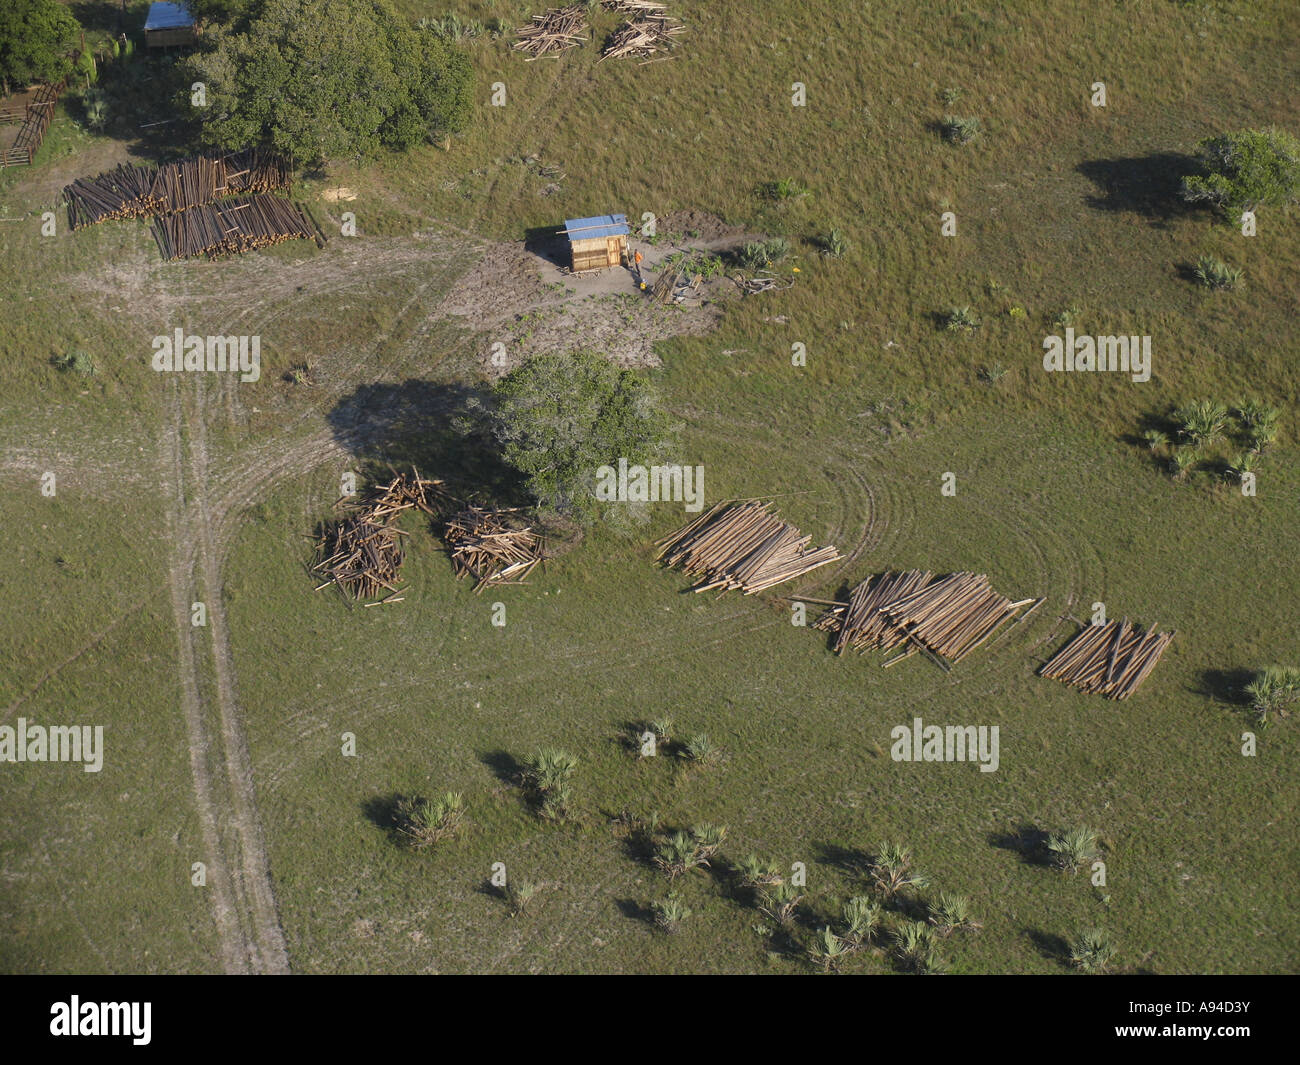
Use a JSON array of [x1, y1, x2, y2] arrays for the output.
[[326, 380, 528, 506]]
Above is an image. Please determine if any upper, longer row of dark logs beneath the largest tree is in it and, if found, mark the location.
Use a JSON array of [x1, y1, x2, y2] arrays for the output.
[[64, 148, 293, 229]]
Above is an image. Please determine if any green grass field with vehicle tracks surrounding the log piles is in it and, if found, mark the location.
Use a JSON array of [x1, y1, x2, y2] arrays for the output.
[[0, 0, 1300, 974]]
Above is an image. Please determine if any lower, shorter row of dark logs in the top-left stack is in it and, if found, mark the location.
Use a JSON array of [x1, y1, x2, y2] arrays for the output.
[[153, 192, 324, 260]]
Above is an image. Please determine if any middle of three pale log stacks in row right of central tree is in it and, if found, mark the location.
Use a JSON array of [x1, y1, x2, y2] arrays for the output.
[[814, 570, 1043, 668]]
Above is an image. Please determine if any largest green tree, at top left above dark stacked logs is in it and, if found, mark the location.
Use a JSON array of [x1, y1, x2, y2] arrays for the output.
[[185, 0, 473, 164]]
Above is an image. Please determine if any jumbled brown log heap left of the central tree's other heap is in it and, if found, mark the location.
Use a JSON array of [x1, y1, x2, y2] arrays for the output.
[[312, 472, 450, 606]]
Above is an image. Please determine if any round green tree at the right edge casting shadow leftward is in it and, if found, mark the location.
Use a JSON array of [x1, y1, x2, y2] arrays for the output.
[[1183, 129, 1300, 211]]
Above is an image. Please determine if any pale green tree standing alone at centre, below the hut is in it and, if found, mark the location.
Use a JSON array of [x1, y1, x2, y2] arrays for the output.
[[493, 352, 672, 521]]
